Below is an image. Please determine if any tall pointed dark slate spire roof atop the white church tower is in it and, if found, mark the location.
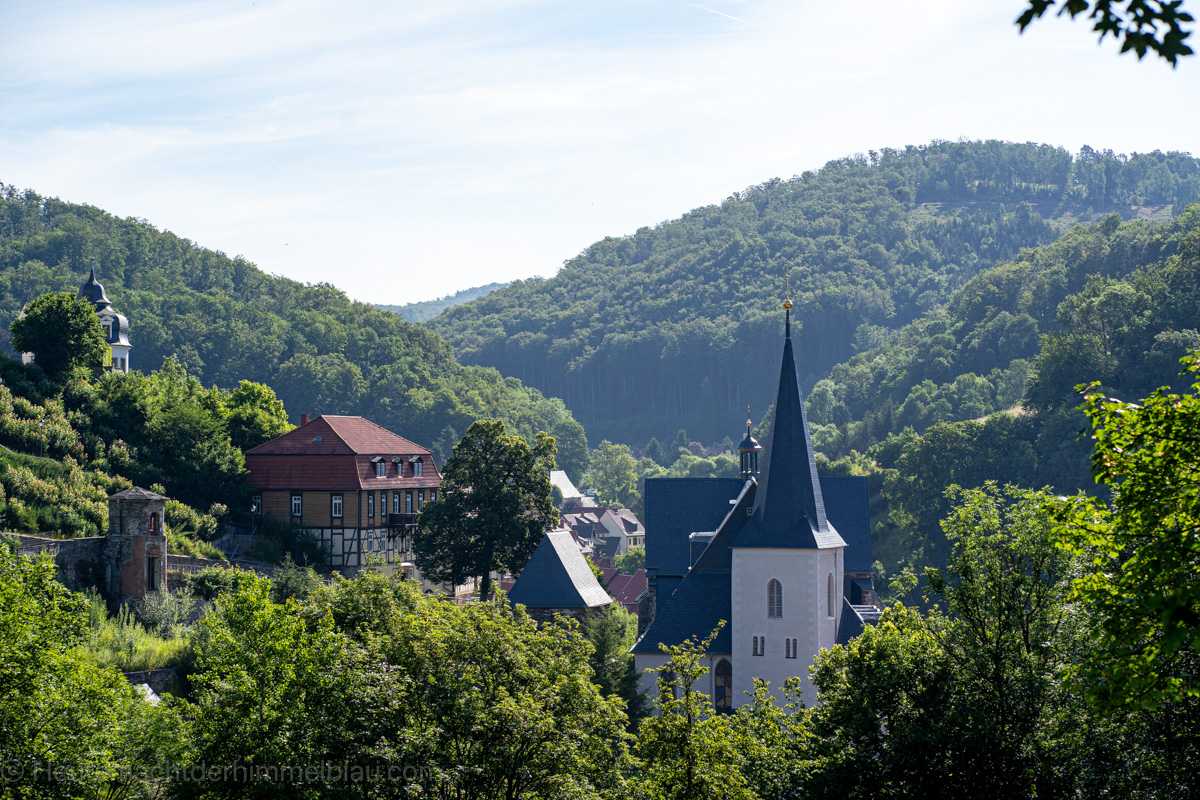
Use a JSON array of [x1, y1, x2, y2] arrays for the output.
[[733, 311, 846, 549]]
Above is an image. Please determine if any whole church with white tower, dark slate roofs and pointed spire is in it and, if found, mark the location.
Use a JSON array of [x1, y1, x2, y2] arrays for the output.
[[632, 300, 881, 711]]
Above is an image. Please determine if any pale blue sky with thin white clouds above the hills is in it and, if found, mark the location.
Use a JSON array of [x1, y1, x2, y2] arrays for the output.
[[0, 0, 1200, 303]]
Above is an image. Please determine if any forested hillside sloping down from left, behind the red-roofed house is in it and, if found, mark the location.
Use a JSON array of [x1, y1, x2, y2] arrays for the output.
[[0, 185, 587, 477]]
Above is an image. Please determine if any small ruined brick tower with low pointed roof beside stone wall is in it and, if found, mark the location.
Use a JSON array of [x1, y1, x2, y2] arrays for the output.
[[104, 486, 167, 603]]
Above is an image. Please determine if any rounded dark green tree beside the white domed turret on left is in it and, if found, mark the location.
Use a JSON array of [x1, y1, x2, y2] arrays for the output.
[[8, 291, 112, 378]]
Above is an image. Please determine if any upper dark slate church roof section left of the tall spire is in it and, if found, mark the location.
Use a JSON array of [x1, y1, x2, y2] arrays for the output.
[[644, 477, 744, 576]]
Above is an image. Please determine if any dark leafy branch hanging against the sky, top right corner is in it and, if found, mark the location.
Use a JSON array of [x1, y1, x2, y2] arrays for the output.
[[1016, 0, 1194, 67]]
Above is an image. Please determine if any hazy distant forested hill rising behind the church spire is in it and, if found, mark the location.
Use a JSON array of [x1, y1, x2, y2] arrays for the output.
[[428, 142, 1200, 446]]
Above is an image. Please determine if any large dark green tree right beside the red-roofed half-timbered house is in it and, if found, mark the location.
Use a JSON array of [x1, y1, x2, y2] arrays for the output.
[[413, 420, 558, 600]]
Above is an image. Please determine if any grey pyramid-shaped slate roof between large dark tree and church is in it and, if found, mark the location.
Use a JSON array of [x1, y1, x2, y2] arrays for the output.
[[509, 530, 612, 608]]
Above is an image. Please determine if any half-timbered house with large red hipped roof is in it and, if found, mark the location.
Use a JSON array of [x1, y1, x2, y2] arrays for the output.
[[246, 415, 442, 578]]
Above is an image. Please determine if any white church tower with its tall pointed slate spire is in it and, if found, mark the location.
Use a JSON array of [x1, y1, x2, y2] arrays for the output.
[[731, 291, 846, 703]]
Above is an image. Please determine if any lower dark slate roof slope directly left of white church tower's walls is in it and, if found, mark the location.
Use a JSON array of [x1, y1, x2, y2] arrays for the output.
[[631, 572, 733, 654]]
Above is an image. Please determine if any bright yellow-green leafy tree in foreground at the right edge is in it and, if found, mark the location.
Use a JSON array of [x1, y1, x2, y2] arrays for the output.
[[1062, 353, 1200, 706]]
